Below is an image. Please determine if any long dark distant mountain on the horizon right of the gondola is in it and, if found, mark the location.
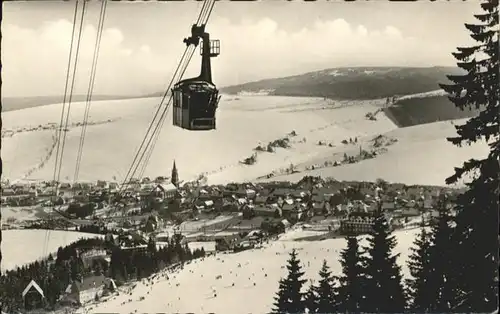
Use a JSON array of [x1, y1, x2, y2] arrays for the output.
[[221, 67, 462, 100]]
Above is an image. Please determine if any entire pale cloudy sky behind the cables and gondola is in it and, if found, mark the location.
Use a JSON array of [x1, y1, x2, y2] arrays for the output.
[[1, 0, 479, 96]]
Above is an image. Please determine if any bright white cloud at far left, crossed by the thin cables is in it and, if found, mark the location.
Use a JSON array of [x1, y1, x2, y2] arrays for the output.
[[2, 20, 167, 96]]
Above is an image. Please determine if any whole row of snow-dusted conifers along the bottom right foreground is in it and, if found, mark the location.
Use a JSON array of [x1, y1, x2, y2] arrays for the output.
[[272, 201, 497, 314]]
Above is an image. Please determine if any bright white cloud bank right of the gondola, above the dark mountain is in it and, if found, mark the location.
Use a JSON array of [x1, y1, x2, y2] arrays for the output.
[[209, 15, 448, 81]]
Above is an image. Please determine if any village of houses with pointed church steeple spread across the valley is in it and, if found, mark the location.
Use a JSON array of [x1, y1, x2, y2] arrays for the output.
[[2, 161, 458, 308]]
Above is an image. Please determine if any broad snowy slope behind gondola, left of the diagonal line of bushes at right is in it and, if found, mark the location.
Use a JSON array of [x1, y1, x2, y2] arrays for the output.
[[2, 96, 396, 183]]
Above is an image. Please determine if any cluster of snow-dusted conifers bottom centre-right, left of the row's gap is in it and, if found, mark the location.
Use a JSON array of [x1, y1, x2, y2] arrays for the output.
[[272, 212, 408, 313]]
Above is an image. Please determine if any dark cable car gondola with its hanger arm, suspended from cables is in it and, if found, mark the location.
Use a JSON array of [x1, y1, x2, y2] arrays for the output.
[[172, 25, 220, 131]]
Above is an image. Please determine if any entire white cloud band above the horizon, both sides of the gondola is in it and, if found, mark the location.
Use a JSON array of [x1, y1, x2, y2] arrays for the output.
[[2, 18, 449, 96]]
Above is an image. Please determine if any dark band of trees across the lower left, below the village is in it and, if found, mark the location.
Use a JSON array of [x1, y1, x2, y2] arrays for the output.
[[0, 235, 205, 313]]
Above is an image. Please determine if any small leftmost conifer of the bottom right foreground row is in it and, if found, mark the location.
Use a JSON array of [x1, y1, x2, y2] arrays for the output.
[[273, 249, 306, 313]]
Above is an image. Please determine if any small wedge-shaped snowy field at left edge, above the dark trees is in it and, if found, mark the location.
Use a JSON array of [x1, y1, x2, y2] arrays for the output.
[[1, 230, 102, 272]]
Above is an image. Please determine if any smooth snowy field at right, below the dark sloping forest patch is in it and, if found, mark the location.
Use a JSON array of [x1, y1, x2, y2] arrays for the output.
[[264, 119, 489, 185]]
